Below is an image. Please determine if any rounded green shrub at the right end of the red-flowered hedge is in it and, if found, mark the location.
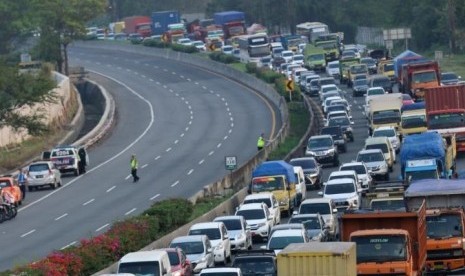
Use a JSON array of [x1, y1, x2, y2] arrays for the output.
[[144, 198, 194, 229]]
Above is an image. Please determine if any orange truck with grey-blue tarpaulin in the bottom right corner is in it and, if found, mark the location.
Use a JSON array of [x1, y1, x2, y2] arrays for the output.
[[405, 179, 465, 274]]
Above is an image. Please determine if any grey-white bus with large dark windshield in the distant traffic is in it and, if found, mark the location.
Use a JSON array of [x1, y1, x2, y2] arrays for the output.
[[238, 34, 271, 63]]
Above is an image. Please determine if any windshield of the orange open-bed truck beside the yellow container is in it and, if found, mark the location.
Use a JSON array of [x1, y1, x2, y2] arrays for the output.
[[351, 235, 407, 263]]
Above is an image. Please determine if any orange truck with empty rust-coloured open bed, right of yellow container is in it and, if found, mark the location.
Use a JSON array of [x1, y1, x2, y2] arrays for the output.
[[340, 203, 426, 276]]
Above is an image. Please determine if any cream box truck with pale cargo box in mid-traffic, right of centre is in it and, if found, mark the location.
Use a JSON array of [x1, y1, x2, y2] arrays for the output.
[[367, 93, 402, 136]]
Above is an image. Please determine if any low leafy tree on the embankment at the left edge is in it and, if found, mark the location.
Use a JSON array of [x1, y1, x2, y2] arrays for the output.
[[0, 63, 56, 135]]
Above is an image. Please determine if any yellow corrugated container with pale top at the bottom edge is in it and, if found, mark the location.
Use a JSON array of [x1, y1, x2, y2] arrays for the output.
[[277, 242, 357, 276]]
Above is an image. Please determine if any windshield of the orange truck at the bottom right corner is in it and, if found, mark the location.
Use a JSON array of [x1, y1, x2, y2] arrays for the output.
[[426, 214, 463, 239]]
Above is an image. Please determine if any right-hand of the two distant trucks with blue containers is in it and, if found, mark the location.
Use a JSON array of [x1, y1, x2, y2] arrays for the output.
[[213, 11, 246, 40]]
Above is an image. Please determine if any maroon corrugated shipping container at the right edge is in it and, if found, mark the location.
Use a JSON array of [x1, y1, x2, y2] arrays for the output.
[[425, 85, 465, 113]]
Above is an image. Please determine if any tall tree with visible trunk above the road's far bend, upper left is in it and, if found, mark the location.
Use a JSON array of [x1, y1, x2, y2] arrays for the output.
[[30, 0, 107, 75]]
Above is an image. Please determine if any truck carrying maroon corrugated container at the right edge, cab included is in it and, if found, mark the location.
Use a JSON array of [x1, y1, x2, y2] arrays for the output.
[[425, 85, 465, 152]]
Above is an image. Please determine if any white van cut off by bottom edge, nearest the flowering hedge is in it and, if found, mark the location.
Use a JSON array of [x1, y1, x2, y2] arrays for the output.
[[117, 250, 171, 276]]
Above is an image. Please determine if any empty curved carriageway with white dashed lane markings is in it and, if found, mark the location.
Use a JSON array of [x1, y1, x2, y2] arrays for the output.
[[0, 42, 281, 269]]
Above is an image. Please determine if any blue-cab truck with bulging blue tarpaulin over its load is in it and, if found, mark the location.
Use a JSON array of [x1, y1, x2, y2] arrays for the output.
[[400, 132, 456, 183]]
